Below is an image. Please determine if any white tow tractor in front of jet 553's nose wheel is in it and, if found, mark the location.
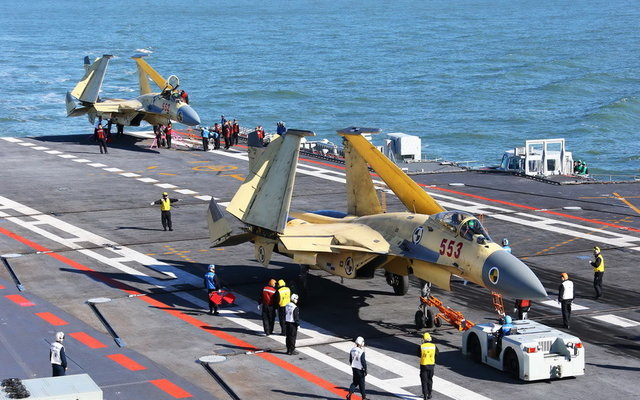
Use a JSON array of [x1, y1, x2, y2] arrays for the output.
[[462, 320, 585, 381]]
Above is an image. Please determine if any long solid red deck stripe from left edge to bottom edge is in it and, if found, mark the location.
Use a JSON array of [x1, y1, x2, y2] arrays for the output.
[[0, 227, 358, 400]]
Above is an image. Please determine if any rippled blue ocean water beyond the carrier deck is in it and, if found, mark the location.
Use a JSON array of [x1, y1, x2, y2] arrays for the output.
[[0, 0, 640, 175]]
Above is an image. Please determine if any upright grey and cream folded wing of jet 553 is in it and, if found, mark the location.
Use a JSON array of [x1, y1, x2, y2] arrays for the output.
[[227, 129, 315, 233]]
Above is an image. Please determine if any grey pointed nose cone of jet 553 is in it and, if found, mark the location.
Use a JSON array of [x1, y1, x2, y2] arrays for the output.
[[482, 250, 547, 300]]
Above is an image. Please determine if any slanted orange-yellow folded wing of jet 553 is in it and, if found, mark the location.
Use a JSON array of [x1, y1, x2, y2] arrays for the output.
[[338, 127, 445, 214]]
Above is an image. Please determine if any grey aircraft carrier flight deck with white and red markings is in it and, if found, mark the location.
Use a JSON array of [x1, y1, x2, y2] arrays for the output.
[[0, 135, 640, 400]]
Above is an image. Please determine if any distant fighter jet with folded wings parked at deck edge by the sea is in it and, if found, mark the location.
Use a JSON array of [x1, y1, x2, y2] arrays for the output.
[[66, 54, 200, 126]]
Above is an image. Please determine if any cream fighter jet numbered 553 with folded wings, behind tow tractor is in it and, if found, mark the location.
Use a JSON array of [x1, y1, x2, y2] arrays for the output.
[[209, 128, 547, 299]]
